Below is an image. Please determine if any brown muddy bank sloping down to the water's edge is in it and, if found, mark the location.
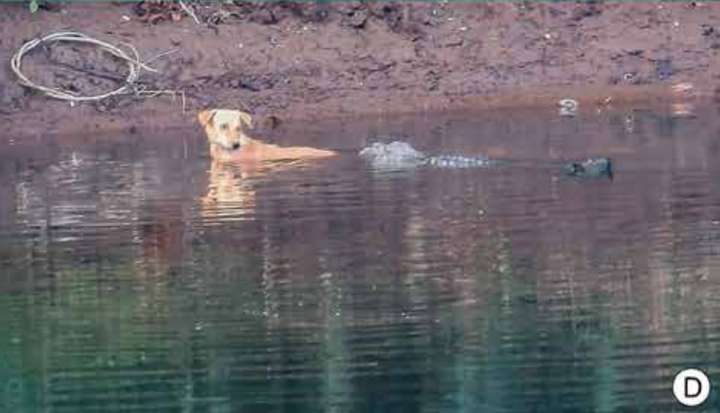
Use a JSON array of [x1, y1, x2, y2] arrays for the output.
[[0, 1, 720, 136]]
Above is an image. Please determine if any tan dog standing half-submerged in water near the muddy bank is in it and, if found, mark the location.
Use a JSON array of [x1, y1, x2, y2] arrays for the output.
[[198, 109, 337, 162]]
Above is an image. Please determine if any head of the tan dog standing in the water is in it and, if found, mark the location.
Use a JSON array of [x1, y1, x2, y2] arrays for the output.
[[198, 109, 253, 150]]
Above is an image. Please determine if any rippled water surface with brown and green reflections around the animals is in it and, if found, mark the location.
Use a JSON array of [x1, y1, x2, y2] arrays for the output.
[[0, 104, 720, 413]]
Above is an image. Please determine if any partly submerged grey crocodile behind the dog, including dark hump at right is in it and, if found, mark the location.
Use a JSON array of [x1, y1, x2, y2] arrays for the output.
[[359, 141, 613, 179]]
